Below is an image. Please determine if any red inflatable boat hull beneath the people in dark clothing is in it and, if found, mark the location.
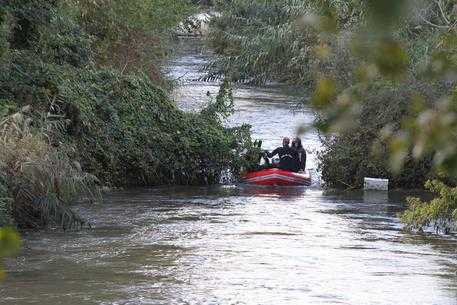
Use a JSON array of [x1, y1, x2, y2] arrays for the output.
[[242, 168, 311, 186]]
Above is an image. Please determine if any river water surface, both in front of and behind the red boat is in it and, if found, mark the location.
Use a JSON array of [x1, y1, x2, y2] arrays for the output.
[[0, 41, 457, 305]]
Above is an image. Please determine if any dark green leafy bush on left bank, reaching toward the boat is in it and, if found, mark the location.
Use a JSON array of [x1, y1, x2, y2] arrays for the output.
[[57, 70, 251, 185]]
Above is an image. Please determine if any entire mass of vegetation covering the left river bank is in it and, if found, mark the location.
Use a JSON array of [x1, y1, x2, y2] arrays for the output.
[[0, 0, 250, 229]]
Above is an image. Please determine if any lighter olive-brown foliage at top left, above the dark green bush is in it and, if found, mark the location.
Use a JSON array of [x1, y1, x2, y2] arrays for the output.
[[62, 0, 196, 82]]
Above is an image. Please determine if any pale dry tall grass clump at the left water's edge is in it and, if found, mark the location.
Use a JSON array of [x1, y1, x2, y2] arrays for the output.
[[0, 108, 99, 230]]
